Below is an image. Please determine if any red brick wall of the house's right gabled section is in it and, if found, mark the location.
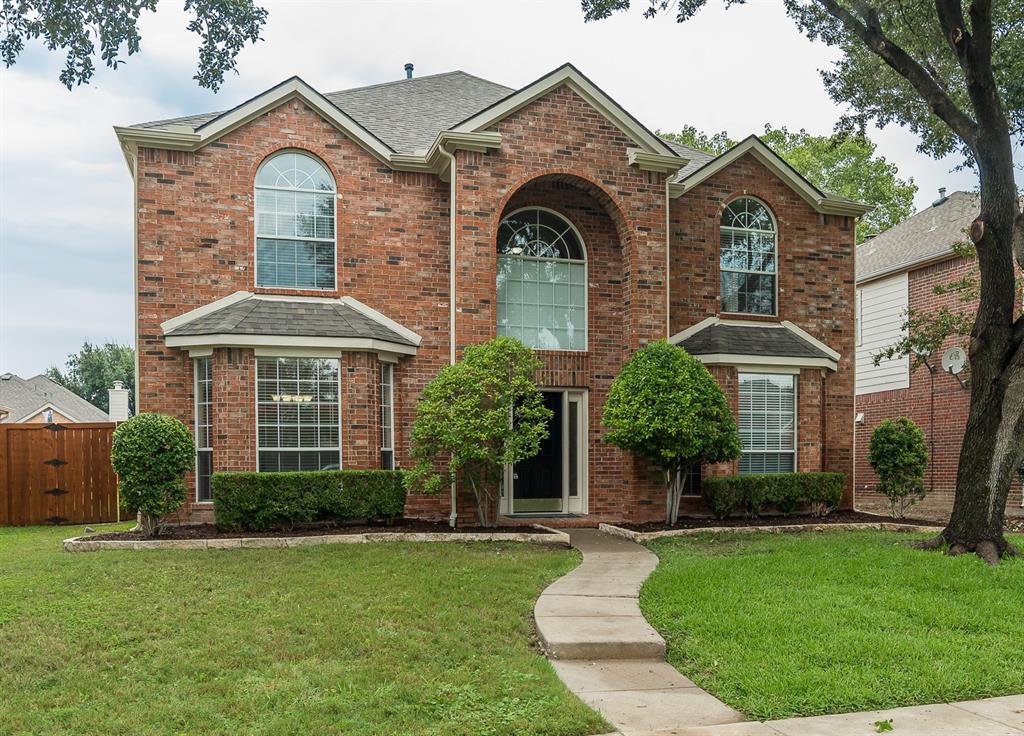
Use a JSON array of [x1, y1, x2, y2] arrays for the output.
[[671, 156, 855, 507]]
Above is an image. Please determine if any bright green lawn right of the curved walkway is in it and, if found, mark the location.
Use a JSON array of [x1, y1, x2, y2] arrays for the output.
[[640, 532, 1024, 720]]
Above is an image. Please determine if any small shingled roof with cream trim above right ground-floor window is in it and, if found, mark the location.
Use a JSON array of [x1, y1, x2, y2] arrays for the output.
[[669, 317, 840, 371]]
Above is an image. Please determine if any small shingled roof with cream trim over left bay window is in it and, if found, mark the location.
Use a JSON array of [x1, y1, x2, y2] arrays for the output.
[[161, 292, 420, 354]]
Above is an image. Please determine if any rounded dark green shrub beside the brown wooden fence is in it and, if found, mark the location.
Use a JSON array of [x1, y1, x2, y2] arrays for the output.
[[111, 414, 196, 536]]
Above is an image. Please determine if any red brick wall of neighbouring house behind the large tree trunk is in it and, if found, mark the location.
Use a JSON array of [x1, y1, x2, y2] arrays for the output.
[[856, 258, 1021, 521]]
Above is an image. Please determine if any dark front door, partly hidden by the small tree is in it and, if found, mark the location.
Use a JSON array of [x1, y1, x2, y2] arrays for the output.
[[512, 391, 562, 514]]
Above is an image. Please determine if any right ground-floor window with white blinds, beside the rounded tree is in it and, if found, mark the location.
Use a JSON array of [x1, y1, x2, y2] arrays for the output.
[[738, 374, 797, 474]]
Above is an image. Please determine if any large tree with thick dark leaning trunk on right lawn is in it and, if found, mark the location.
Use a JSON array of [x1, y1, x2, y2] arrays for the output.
[[582, 0, 1024, 564]]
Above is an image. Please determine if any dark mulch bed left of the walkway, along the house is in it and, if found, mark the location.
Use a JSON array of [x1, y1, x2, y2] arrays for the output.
[[86, 519, 551, 542]]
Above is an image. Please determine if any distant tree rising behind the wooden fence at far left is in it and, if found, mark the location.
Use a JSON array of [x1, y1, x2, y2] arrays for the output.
[[46, 342, 135, 414]]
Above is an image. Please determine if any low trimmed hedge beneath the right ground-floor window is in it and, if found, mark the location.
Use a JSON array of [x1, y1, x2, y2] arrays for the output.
[[701, 473, 844, 519]]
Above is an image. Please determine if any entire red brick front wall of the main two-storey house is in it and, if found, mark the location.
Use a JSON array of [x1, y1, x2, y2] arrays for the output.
[[137, 87, 853, 519]]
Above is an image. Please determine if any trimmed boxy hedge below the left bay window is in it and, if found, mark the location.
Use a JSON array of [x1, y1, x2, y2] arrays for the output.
[[210, 470, 406, 531]]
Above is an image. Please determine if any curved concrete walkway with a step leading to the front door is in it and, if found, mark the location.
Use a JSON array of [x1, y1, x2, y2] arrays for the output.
[[534, 529, 743, 736]]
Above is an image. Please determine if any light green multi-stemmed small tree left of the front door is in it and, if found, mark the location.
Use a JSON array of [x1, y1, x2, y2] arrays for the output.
[[408, 337, 551, 526]]
